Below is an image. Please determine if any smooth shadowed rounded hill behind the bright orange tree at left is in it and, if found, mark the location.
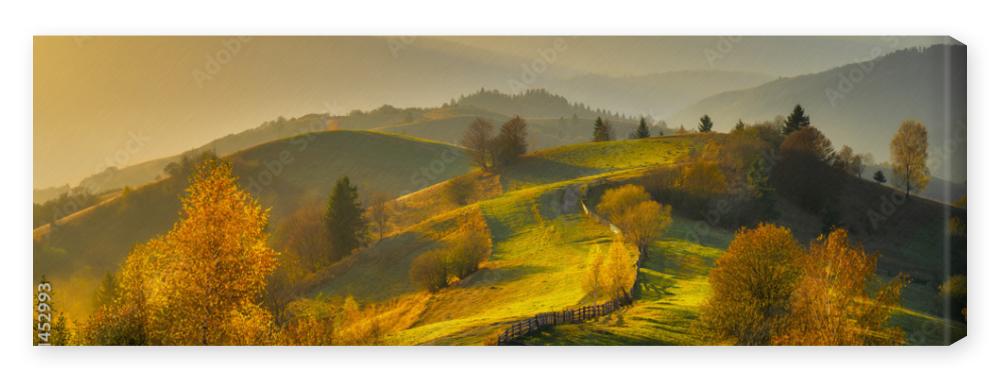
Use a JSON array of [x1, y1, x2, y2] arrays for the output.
[[34, 131, 469, 320]]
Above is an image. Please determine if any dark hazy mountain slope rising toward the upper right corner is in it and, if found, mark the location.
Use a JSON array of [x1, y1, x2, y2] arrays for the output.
[[669, 43, 966, 182]]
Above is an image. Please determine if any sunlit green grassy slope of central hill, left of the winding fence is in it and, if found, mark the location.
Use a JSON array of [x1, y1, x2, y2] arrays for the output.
[[311, 137, 699, 344]]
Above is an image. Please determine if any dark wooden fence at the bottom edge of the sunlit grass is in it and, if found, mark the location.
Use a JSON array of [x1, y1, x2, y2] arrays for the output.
[[497, 295, 632, 345]]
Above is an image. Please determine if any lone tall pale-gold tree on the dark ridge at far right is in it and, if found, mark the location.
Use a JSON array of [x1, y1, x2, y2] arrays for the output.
[[890, 120, 931, 198]]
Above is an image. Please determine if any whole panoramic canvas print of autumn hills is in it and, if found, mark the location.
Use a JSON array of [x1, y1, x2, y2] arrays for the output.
[[33, 36, 968, 346]]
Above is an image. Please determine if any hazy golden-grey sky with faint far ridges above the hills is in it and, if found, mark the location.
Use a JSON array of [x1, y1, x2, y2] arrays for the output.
[[34, 36, 937, 187]]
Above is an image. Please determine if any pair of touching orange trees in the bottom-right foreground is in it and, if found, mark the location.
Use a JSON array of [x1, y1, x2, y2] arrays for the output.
[[699, 224, 906, 345]]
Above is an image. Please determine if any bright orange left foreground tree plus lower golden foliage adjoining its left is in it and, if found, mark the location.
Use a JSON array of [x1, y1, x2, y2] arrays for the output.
[[81, 159, 278, 345]]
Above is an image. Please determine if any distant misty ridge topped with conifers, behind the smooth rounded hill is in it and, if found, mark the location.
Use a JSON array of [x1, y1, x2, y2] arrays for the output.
[[66, 89, 638, 195]]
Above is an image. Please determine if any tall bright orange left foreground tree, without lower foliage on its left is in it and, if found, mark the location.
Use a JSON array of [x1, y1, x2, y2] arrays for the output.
[[156, 161, 278, 345]]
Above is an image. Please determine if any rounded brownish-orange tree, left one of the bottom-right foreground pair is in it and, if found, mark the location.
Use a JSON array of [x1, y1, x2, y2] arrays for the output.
[[699, 224, 805, 345]]
